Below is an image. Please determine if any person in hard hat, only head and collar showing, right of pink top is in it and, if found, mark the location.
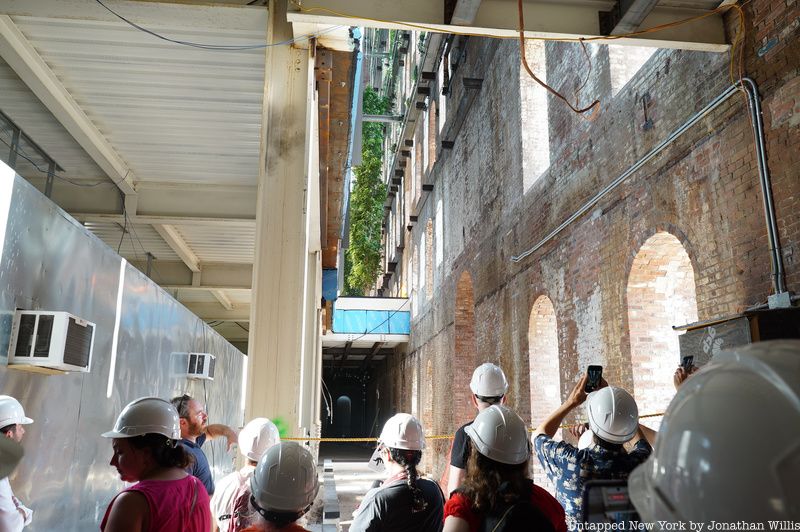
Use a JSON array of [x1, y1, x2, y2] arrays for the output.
[[234, 442, 319, 532]]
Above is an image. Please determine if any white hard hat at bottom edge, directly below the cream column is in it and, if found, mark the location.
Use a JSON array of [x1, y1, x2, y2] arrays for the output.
[[250, 442, 319, 512]]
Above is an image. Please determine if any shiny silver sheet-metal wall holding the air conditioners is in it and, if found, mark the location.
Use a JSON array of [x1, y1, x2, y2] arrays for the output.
[[0, 167, 244, 531]]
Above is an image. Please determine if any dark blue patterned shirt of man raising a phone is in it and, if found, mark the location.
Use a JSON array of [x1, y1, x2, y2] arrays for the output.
[[533, 434, 653, 530]]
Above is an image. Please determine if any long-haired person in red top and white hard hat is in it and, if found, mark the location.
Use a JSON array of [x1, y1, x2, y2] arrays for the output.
[[444, 405, 567, 532]]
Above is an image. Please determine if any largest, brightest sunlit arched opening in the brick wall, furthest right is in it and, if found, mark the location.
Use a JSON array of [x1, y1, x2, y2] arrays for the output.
[[627, 231, 697, 428]]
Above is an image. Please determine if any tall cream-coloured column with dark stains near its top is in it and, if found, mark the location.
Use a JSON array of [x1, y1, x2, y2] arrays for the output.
[[245, 0, 317, 435]]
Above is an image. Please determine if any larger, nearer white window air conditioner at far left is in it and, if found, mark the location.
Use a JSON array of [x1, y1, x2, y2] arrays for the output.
[[8, 310, 95, 373]]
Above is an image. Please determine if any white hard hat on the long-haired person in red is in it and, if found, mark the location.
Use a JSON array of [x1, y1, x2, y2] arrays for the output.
[[464, 405, 530, 464]]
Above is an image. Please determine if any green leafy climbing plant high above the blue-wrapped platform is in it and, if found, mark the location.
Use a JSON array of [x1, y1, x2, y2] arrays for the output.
[[343, 87, 390, 296]]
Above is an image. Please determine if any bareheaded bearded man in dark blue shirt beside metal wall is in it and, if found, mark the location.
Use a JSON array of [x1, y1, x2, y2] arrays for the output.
[[171, 394, 237, 496]]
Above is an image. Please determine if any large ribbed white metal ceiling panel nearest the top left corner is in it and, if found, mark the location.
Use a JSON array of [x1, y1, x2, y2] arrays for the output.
[[14, 14, 266, 185]]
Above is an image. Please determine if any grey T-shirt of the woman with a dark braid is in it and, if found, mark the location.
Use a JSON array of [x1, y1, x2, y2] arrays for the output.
[[350, 478, 444, 532]]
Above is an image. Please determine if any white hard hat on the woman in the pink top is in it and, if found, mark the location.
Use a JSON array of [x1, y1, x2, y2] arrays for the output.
[[102, 397, 181, 440]]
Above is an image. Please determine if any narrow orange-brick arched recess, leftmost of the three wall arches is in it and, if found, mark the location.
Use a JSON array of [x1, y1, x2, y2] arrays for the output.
[[452, 272, 477, 428]]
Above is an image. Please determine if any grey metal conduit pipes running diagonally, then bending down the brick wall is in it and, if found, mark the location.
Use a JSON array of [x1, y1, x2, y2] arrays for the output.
[[511, 78, 786, 293]]
